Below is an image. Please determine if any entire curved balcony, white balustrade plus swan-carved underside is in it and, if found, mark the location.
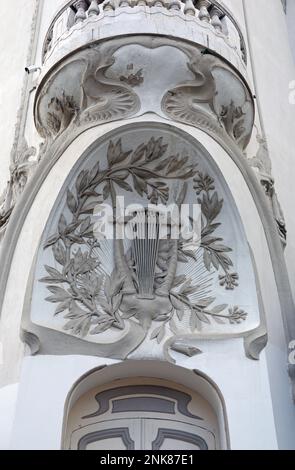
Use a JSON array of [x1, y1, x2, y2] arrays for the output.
[[34, 0, 255, 149]]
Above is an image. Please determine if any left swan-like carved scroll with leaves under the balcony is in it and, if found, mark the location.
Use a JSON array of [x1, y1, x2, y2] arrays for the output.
[[35, 45, 141, 142]]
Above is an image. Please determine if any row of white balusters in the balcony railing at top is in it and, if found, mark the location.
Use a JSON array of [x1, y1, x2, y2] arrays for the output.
[[43, 0, 247, 64]]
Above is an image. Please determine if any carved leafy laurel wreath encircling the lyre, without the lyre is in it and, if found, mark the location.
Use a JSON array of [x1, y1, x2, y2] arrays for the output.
[[41, 138, 247, 343]]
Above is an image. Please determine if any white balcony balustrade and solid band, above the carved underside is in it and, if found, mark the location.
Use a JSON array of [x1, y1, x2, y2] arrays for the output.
[[42, 0, 247, 76]]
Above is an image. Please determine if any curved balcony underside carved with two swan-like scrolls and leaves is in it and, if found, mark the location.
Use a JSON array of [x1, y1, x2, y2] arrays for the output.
[[35, 36, 254, 149]]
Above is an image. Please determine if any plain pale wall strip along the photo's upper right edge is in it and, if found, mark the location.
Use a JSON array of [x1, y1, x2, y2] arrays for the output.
[[245, 0, 295, 306]]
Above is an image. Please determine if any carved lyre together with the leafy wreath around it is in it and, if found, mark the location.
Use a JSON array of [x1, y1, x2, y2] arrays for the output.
[[40, 136, 251, 358]]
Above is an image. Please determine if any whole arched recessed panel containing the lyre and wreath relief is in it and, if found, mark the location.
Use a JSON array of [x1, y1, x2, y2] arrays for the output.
[[23, 124, 265, 360]]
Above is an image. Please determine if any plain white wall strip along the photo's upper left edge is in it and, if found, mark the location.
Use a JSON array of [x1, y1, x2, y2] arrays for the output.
[[0, 0, 35, 194]]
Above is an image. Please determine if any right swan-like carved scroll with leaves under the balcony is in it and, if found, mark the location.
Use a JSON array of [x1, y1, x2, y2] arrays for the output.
[[162, 48, 254, 149]]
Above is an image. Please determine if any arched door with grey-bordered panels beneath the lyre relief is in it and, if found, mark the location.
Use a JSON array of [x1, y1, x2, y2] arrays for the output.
[[62, 371, 226, 450]]
